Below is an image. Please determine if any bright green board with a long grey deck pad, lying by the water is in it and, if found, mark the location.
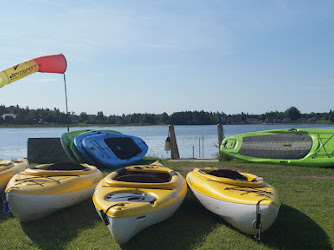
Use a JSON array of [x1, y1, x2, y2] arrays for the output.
[[220, 129, 334, 166]]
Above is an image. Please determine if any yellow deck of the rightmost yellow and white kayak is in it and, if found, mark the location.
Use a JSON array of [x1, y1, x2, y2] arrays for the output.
[[186, 167, 280, 207]]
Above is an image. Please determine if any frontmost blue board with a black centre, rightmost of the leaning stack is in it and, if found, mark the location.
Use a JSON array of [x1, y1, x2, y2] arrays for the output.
[[82, 132, 148, 168]]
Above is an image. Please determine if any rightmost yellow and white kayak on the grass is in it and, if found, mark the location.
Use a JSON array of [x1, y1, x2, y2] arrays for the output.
[[186, 167, 281, 239]]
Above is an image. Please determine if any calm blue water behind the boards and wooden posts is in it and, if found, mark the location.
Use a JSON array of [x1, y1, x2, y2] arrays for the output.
[[0, 124, 334, 160]]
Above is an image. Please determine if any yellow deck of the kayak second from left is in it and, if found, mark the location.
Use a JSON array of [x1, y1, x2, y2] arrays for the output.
[[6, 164, 102, 195]]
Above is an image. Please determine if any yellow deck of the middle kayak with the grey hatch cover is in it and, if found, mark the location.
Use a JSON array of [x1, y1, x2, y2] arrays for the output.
[[93, 162, 187, 218]]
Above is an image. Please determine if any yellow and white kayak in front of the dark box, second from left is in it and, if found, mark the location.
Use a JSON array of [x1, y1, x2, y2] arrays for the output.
[[5, 162, 102, 221]]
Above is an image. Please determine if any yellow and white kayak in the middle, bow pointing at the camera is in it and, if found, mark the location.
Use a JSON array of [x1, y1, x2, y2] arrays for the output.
[[93, 162, 187, 244]]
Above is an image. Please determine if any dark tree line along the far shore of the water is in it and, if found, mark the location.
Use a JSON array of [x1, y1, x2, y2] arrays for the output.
[[0, 105, 334, 125]]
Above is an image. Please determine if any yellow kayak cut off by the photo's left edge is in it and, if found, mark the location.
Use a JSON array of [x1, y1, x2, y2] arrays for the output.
[[0, 158, 29, 194]]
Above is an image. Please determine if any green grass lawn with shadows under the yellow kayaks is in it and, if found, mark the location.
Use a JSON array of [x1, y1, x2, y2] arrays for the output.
[[0, 159, 334, 250]]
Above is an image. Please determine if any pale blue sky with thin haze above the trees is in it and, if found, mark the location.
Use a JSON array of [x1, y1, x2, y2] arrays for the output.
[[0, 0, 334, 115]]
